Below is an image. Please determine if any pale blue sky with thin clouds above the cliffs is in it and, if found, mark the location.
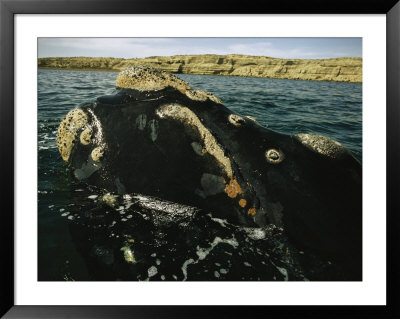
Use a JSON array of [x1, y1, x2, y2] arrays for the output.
[[38, 38, 362, 59]]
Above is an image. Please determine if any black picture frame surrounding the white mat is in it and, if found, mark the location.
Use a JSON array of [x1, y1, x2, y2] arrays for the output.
[[0, 0, 400, 318]]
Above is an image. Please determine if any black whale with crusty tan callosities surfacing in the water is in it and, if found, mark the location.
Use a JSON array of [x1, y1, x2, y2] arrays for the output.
[[56, 65, 362, 280]]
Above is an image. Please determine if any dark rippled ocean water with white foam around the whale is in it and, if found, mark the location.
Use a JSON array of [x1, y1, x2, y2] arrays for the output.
[[38, 70, 362, 280]]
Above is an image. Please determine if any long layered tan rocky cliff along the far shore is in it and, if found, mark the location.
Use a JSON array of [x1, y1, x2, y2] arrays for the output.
[[38, 54, 362, 83]]
